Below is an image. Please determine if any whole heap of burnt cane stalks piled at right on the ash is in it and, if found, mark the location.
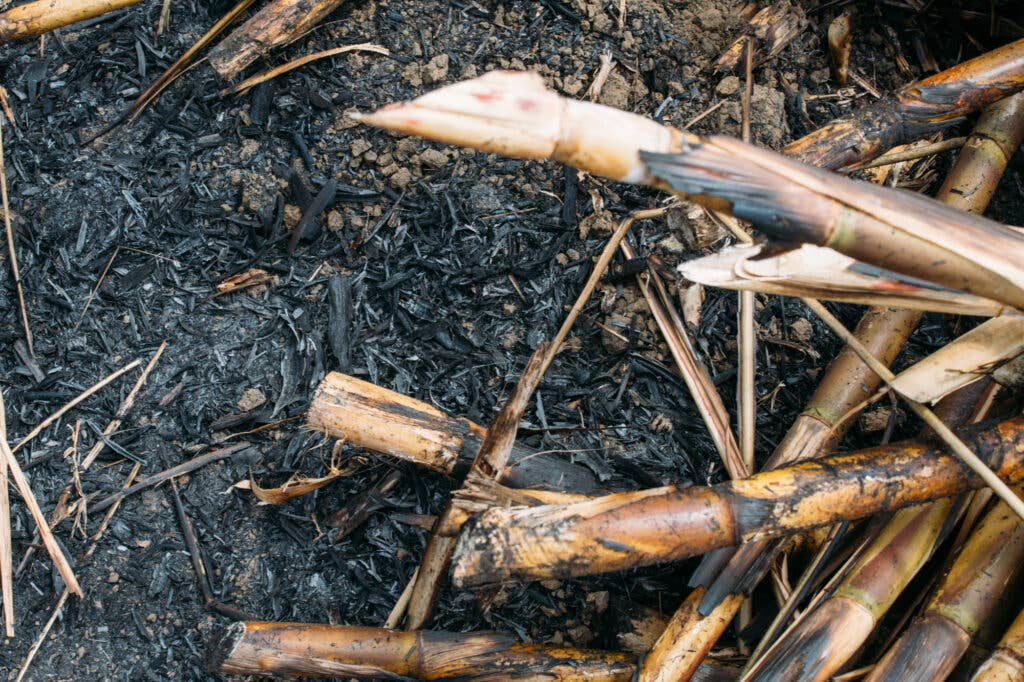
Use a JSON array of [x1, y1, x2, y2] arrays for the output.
[[210, 34, 1024, 682]]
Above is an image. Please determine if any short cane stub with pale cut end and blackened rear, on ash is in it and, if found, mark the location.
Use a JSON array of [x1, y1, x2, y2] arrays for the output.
[[306, 372, 601, 493]]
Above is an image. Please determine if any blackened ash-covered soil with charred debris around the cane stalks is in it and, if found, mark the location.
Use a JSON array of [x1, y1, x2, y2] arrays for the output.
[[0, 0, 1024, 680]]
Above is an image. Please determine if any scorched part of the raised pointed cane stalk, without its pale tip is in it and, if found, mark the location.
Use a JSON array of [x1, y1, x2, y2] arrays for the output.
[[640, 136, 1024, 309]]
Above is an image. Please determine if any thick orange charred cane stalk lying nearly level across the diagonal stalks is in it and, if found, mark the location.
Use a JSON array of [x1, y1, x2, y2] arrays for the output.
[[453, 418, 1024, 587]]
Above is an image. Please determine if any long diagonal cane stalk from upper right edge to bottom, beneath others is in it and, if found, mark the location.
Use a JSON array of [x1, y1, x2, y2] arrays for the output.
[[640, 94, 1024, 682]]
